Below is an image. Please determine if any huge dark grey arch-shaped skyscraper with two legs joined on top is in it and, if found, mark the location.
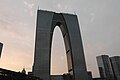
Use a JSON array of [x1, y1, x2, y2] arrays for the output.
[[33, 10, 88, 80]]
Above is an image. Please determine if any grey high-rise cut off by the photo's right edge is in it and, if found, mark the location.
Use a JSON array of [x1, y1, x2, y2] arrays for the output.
[[110, 56, 120, 80]]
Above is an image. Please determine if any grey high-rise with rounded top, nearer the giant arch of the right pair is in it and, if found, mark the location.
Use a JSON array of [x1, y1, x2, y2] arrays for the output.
[[97, 55, 114, 80]]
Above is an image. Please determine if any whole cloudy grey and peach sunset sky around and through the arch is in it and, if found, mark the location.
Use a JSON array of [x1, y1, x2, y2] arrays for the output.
[[0, 0, 120, 77]]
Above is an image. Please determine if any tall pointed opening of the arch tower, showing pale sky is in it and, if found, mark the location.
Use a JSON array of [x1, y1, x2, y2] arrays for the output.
[[50, 26, 68, 75]]
